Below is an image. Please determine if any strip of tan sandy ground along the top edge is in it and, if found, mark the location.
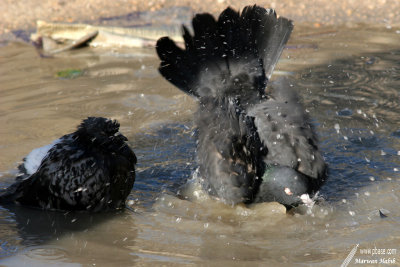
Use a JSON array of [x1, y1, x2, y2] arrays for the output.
[[0, 0, 400, 39]]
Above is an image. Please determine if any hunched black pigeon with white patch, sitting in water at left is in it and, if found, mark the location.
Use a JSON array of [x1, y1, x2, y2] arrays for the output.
[[0, 117, 136, 211]]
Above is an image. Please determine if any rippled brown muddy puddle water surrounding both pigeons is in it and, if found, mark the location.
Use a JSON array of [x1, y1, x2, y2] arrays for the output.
[[0, 26, 400, 266]]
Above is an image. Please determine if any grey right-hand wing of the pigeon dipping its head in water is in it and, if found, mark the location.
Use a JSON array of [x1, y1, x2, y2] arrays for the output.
[[248, 79, 326, 181]]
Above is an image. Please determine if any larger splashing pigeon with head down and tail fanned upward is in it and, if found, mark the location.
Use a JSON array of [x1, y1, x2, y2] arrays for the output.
[[156, 5, 327, 206]]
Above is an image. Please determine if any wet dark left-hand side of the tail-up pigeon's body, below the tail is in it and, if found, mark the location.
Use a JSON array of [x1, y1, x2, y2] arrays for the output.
[[196, 97, 267, 204]]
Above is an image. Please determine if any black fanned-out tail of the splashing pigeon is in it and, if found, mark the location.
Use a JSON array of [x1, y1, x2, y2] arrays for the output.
[[157, 6, 293, 97]]
